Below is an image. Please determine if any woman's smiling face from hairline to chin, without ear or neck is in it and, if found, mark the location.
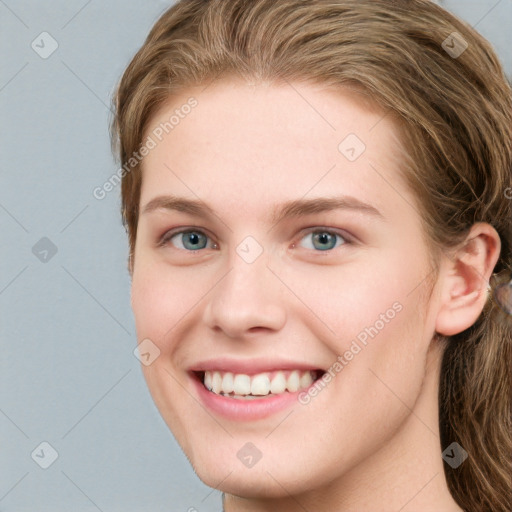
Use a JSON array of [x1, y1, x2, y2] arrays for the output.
[[132, 79, 436, 496]]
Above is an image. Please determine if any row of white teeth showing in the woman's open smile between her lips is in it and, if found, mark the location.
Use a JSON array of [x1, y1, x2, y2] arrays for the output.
[[193, 369, 325, 400]]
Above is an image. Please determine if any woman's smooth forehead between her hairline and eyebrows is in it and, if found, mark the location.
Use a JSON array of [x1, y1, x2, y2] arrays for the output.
[[141, 80, 408, 220]]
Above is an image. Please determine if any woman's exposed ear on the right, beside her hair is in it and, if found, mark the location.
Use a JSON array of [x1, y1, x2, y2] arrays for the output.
[[436, 222, 501, 336]]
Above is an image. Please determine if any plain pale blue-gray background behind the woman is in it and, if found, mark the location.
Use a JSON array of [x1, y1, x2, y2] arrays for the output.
[[0, 0, 512, 512]]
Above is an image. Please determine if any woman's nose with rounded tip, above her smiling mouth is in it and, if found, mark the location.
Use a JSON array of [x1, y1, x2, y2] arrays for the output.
[[204, 252, 286, 338]]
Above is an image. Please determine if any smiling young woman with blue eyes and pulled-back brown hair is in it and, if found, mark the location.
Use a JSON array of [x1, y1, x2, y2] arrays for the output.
[[113, 0, 512, 512]]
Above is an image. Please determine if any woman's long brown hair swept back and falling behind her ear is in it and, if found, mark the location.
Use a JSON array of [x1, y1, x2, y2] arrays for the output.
[[112, 0, 512, 512]]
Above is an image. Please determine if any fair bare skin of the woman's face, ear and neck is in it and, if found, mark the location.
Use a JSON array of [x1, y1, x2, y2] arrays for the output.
[[132, 79, 500, 512]]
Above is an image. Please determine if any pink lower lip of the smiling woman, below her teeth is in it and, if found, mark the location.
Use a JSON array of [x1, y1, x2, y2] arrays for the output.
[[192, 376, 307, 421]]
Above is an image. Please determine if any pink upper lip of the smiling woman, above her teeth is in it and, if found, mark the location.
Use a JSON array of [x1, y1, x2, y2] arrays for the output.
[[189, 357, 322, 375]]
